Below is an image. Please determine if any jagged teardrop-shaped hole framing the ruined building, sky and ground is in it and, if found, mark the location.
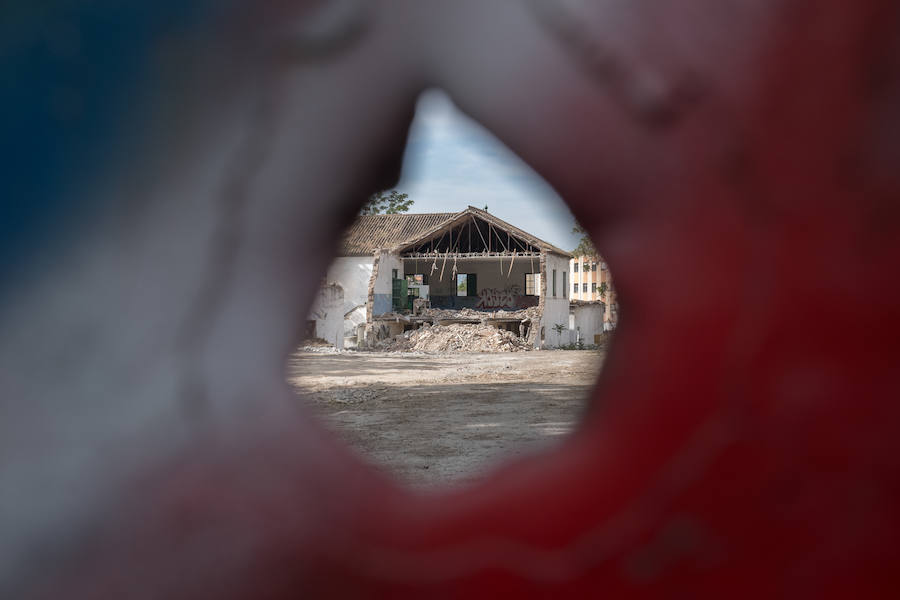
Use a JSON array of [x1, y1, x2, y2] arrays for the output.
[[287, 91, 618, 487]]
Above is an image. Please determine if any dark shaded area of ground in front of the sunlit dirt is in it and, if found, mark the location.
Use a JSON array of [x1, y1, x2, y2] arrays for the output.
[[298, 382, 592, 486]]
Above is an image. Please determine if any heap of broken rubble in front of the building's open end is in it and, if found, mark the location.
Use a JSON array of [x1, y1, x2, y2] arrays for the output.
[[375, 323, 531, 352]]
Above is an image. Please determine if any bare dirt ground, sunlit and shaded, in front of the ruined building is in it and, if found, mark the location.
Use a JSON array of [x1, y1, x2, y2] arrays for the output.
[[287, 350, 605, 487]]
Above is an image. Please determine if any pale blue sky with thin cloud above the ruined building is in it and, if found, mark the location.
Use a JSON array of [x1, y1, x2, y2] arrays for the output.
[[397, 90, 579, 250]]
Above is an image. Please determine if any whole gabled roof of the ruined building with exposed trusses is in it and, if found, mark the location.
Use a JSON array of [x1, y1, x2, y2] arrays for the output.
[[342, 206, 572, 258]]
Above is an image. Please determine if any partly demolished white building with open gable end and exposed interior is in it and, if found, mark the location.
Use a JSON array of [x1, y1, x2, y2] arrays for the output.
[[309, 206, 572, 348]]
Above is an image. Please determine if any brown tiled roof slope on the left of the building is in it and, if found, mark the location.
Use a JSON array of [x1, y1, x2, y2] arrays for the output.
[[341, 213, 459, 256]]
